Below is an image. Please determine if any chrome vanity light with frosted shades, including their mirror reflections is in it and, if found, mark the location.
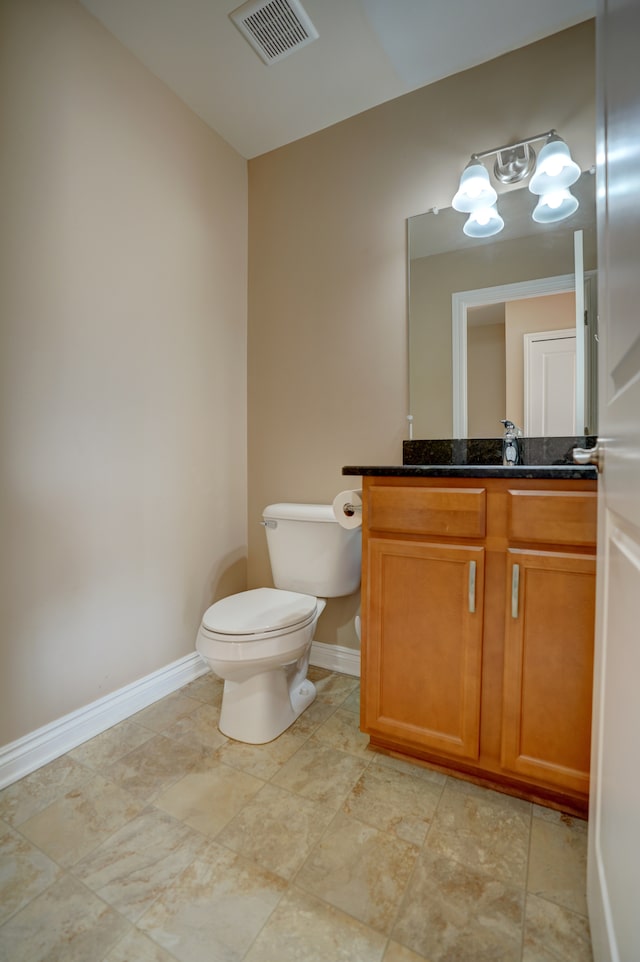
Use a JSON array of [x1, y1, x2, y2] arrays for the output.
[[451, 130, 581, 237]]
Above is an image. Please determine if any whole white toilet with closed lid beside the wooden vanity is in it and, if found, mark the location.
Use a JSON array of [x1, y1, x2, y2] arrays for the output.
[[196, 503, 361, 745]]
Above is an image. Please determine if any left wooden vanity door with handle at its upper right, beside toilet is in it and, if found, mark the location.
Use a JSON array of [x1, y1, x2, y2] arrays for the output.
[[362, 538, 484, 759]]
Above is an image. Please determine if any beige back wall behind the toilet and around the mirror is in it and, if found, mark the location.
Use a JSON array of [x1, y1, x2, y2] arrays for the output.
[[248, 23, 595, 647]]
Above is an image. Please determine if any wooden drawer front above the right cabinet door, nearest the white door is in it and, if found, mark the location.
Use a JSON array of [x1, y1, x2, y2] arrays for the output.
[[508, 489, 597, 545]]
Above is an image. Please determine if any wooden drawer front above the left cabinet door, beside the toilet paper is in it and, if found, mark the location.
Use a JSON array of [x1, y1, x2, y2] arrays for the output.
[[367, 486, 486, 538]]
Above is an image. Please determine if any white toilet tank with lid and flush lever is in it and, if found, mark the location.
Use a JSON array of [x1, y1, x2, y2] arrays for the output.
[[262, 504, 362, 598]]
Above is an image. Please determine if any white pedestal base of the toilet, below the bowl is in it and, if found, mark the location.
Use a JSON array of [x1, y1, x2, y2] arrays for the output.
[[218, 654, 316, 745]]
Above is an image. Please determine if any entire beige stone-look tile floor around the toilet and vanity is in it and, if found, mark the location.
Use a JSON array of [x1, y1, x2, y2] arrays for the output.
[[0, 669, 591, 962]]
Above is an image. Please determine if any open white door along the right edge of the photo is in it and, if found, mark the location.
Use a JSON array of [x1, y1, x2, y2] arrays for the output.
[[588, 0, 640, 962]]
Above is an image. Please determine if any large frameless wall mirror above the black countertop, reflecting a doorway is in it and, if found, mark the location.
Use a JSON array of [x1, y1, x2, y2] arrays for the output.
[[408, 171, 598, 438]]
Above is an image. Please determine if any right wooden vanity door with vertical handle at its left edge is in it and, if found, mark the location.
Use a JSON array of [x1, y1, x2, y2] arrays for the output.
[[501, 549, 596, 795]]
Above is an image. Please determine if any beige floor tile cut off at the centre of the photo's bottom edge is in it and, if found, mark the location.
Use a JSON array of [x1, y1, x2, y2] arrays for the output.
[[245, 889, 386, 962]]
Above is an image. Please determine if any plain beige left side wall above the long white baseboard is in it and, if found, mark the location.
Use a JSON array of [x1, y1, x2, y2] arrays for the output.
[[0, 0, 247, 744]]
